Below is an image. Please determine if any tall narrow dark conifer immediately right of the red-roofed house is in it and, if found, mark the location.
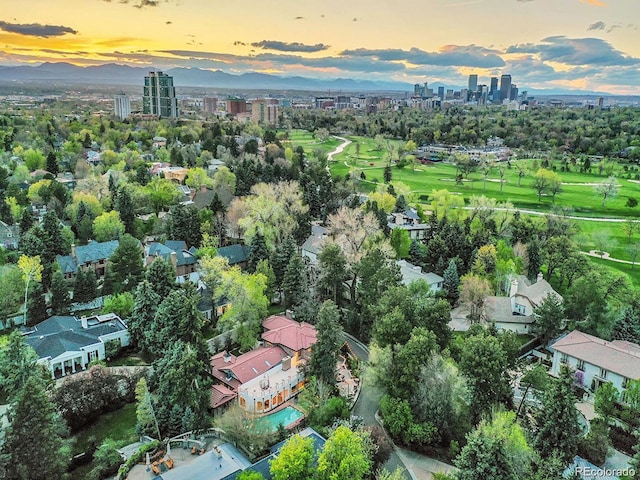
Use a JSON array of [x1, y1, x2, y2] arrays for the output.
[[309, 300, 344, 387]]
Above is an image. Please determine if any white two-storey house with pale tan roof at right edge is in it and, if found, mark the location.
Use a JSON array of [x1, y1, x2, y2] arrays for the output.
[[551, 330, 640, 399]]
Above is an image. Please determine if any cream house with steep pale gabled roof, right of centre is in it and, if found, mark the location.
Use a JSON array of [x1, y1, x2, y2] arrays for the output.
[[483, 273, 562, 333]]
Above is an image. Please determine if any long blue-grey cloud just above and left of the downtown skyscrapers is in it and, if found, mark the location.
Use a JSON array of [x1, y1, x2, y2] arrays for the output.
[[340, 45, 505, 68]]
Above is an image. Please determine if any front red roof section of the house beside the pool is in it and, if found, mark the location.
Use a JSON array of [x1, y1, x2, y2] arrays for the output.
[[211, 347, 287, 388]]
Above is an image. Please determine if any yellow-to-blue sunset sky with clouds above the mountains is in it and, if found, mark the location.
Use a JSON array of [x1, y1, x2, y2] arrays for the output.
[[0, 0, 640, 95]]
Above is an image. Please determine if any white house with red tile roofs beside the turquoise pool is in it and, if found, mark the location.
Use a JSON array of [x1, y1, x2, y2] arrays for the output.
[[211, 315, 317, 413]]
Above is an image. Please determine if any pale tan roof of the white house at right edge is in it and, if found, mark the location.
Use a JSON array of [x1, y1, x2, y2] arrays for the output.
[[552, 330, 640, 380]]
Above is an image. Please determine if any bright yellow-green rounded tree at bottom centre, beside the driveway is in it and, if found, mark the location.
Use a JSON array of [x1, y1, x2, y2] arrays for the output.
[[318, 426, 371, 480]]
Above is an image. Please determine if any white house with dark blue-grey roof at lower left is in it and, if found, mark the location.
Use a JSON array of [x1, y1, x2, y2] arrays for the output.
[[23, 313, 129, 378]]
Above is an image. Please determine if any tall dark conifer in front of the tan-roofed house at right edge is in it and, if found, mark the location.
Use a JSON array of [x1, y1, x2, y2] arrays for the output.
[[535, 366, 580, 465]]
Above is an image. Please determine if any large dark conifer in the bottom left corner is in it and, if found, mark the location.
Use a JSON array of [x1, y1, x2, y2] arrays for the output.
[[2, 376, 71, 480]]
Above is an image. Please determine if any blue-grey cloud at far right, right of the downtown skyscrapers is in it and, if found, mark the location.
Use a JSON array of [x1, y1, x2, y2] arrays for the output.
[[506, 36, 640, 66]]
